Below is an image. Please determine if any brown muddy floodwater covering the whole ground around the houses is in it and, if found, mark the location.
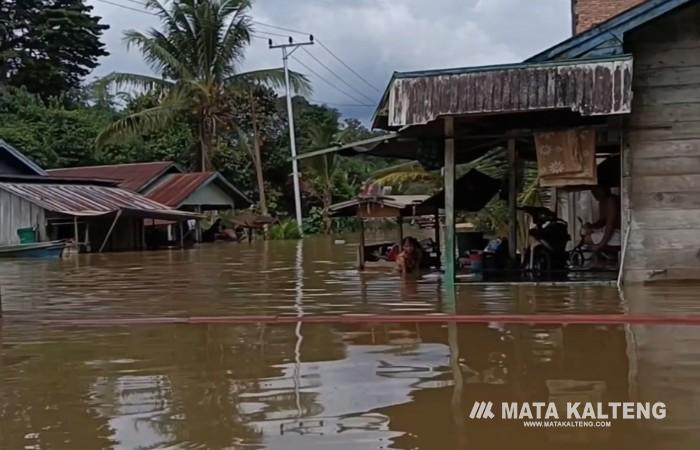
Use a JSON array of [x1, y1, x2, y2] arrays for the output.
[[0, 239, 700, 450]]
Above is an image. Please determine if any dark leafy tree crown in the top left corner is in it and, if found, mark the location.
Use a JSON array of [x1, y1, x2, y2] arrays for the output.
[[0, 0, 109, 100]]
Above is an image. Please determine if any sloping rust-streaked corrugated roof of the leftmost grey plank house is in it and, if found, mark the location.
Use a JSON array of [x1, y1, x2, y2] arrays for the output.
[[0, 183, 197, 219]]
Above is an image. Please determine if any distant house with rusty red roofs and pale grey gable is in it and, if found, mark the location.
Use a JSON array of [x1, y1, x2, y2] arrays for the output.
[[48, 161, 252, 216]]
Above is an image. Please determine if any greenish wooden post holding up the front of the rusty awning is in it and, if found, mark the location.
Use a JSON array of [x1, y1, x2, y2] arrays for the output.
[[443, 117, 456, 286]]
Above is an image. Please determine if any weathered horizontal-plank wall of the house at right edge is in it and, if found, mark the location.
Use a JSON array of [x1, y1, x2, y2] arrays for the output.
[[623, 3, 700, 282]]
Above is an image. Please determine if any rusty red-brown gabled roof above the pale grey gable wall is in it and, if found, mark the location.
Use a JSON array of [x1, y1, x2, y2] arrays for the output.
[[145, 172, 252, 208]]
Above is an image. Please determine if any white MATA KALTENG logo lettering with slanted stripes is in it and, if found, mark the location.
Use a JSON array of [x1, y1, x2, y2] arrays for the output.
[[469, 401, 666, 420]]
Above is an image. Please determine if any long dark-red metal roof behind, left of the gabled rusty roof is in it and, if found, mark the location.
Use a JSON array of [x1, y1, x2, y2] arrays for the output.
[[48, 161, 180, 192]]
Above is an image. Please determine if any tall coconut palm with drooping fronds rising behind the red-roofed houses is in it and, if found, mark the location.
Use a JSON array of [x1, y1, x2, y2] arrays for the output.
[[97, 0, 310, 172]]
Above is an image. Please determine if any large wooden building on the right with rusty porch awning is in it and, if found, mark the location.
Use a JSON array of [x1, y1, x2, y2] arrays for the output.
[[302, 0, 700, 282]]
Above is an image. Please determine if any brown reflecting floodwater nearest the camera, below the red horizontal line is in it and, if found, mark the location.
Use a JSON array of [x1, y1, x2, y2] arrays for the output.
[[0, 324, 699, 449]]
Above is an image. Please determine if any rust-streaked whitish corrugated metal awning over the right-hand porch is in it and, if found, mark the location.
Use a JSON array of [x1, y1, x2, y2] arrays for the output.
[[374, 55, 632, 129]]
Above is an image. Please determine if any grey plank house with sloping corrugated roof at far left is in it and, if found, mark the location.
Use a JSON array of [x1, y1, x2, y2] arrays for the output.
[[0, 140, 198, 251]]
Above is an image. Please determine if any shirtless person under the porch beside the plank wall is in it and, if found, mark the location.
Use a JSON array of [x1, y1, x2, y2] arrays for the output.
[[583, 186, 622, 254]]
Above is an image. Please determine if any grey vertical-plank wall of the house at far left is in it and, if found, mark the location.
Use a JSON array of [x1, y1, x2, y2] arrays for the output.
[[0, 189, 46, 245]]
